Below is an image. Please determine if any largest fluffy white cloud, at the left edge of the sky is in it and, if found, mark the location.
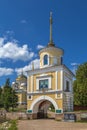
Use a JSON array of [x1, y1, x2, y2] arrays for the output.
[[0, 38, 34, 61]]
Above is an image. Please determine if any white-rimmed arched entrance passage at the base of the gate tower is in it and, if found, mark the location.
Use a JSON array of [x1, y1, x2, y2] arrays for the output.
[[30, 96, 58, 118]]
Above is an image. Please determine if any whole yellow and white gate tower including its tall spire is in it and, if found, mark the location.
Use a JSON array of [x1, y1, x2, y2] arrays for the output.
[[27, 14, 74, 118]]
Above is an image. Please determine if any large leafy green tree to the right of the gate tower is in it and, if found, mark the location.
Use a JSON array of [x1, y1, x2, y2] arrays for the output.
[[74, 63, 87, 106]]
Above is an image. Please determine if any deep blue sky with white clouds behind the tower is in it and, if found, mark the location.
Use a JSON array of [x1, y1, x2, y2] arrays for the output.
[[0, 0, 87, 85]]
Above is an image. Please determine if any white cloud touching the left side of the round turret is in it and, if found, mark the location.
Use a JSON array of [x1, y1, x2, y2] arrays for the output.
[[15, 59, 40, 74]]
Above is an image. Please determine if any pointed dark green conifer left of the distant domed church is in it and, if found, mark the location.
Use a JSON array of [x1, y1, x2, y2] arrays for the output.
[[3, 79, 18, 111]]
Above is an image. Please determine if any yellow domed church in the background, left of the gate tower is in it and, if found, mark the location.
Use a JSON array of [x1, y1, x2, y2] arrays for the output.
[[12, 72, 27, 108]]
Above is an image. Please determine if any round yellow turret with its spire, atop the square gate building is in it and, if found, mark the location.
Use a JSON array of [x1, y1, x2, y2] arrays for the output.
[[39, 12, 64, 68]]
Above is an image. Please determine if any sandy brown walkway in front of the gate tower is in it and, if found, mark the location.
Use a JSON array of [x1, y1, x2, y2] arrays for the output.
[[18, 119, 87, 130]]
